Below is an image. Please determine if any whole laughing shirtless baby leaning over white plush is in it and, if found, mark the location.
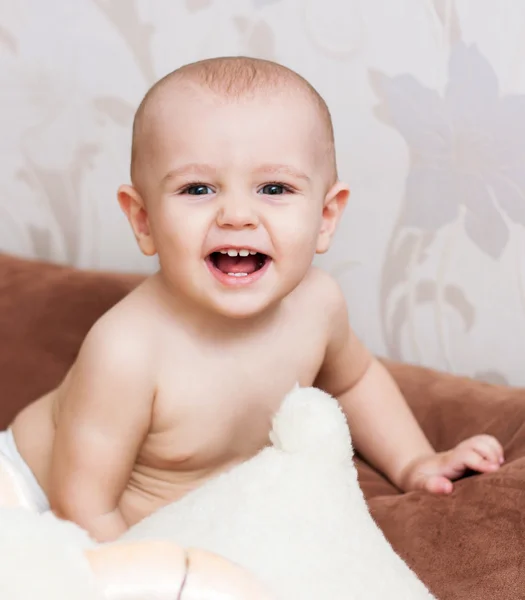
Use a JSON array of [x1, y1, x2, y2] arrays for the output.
[[0, 57, 503, 541]]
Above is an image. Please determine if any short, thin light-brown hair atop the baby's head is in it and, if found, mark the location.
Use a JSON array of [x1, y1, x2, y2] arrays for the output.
[[131, 57, 337, 185]]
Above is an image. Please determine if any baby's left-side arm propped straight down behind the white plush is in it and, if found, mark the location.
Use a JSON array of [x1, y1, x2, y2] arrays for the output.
[[49, 322, 154, 542]]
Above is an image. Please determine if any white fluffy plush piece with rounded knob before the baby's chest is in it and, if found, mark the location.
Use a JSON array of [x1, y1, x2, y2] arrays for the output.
[[122, 388, 433, 600]]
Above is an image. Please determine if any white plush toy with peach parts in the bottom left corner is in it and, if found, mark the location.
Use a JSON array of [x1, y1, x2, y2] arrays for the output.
[[0, 454, 272, 600]]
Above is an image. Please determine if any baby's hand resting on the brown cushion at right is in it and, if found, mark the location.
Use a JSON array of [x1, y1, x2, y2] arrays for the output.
[[403, 435, 504, 494]]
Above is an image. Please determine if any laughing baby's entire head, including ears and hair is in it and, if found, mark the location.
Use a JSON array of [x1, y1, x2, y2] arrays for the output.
[[119, 57, 349, 317]]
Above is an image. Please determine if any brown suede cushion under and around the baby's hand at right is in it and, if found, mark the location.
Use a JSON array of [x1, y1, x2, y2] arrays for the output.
[[358, 362, 525, 600]]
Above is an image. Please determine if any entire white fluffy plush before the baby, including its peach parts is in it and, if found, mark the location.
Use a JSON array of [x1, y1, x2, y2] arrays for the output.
[[0, 387, 433, 600]]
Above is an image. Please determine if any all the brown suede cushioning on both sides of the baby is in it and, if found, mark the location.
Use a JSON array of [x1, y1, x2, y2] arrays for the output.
[[0, 255, 525, 600]]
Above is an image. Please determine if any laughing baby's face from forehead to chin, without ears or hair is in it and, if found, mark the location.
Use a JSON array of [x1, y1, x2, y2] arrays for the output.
[[135, 90, 340, 317]]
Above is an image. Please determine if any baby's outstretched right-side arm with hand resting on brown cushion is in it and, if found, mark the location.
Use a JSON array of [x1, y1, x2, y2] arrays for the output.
[[316, 282, 502, 493]]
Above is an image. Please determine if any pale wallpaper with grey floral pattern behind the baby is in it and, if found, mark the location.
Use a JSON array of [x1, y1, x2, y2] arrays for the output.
[[0, 0, 525, 385]]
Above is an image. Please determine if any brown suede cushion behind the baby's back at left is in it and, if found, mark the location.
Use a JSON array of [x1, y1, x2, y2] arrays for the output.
[[0, 254, 142, 429]]
